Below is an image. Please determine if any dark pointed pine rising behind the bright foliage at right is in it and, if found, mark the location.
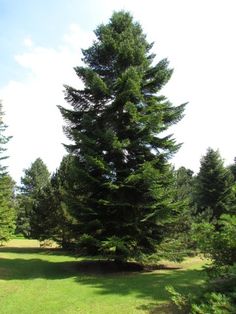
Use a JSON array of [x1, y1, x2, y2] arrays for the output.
[[196, 148, 235, 220]]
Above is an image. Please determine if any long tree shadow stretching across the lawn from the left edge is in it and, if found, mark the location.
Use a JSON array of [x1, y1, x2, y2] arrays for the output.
[[0, 248, 204, 313]]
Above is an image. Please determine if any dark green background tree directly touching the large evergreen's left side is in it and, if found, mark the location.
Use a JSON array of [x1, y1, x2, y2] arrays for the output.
[[27, 155, 76, 249]]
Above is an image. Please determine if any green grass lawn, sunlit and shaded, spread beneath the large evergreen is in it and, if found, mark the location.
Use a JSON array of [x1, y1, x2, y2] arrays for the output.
[[0, 239, 205, 314]]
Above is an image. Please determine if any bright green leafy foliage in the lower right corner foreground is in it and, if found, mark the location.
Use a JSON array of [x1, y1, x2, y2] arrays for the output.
[[168, 209, 236, 314]]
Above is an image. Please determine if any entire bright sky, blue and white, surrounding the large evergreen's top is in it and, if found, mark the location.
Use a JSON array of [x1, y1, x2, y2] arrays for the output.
[[0, 0, 236, 182]]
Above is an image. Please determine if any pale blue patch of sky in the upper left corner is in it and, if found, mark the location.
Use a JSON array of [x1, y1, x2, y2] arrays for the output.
[[0, 0, 99, 84]]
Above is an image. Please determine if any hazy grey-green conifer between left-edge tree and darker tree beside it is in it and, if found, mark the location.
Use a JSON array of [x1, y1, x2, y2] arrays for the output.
[[17, 158, 50, 237]]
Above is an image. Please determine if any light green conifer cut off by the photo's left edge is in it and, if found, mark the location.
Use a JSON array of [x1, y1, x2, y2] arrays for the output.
[[0, 103, 15, 244]]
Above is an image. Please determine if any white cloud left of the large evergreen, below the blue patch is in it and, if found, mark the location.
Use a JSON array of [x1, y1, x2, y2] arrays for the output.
[[0, 25, 91, 181]]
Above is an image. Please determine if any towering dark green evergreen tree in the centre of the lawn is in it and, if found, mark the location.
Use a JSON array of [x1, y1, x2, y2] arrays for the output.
[[60, 12, 184, 259]]
